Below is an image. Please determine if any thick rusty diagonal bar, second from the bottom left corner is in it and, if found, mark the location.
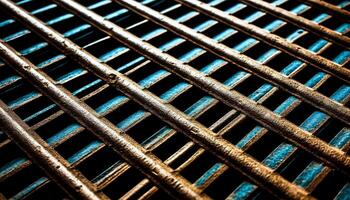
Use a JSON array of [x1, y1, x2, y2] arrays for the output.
[[1, 39, 207, 199]]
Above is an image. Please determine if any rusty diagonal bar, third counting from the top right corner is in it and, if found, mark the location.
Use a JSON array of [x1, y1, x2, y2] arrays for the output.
[[170, 0, 350, 83]]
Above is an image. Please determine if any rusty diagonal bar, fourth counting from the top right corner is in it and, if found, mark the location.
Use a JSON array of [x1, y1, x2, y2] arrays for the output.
[[114, 0, 350, 125]]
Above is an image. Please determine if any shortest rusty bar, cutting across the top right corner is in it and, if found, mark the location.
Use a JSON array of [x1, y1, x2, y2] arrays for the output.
[[299, 0, 350, 21]]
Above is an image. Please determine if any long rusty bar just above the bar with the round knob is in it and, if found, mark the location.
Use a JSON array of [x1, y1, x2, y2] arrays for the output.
[[47, 0, 350, 174]]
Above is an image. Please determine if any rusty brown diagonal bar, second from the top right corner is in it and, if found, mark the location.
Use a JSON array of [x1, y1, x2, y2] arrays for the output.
[[232, 0, 350, 49]]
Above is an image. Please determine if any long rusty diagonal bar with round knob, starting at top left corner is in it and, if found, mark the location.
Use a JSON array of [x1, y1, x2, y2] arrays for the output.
[[1, 0, 314, 199]]
